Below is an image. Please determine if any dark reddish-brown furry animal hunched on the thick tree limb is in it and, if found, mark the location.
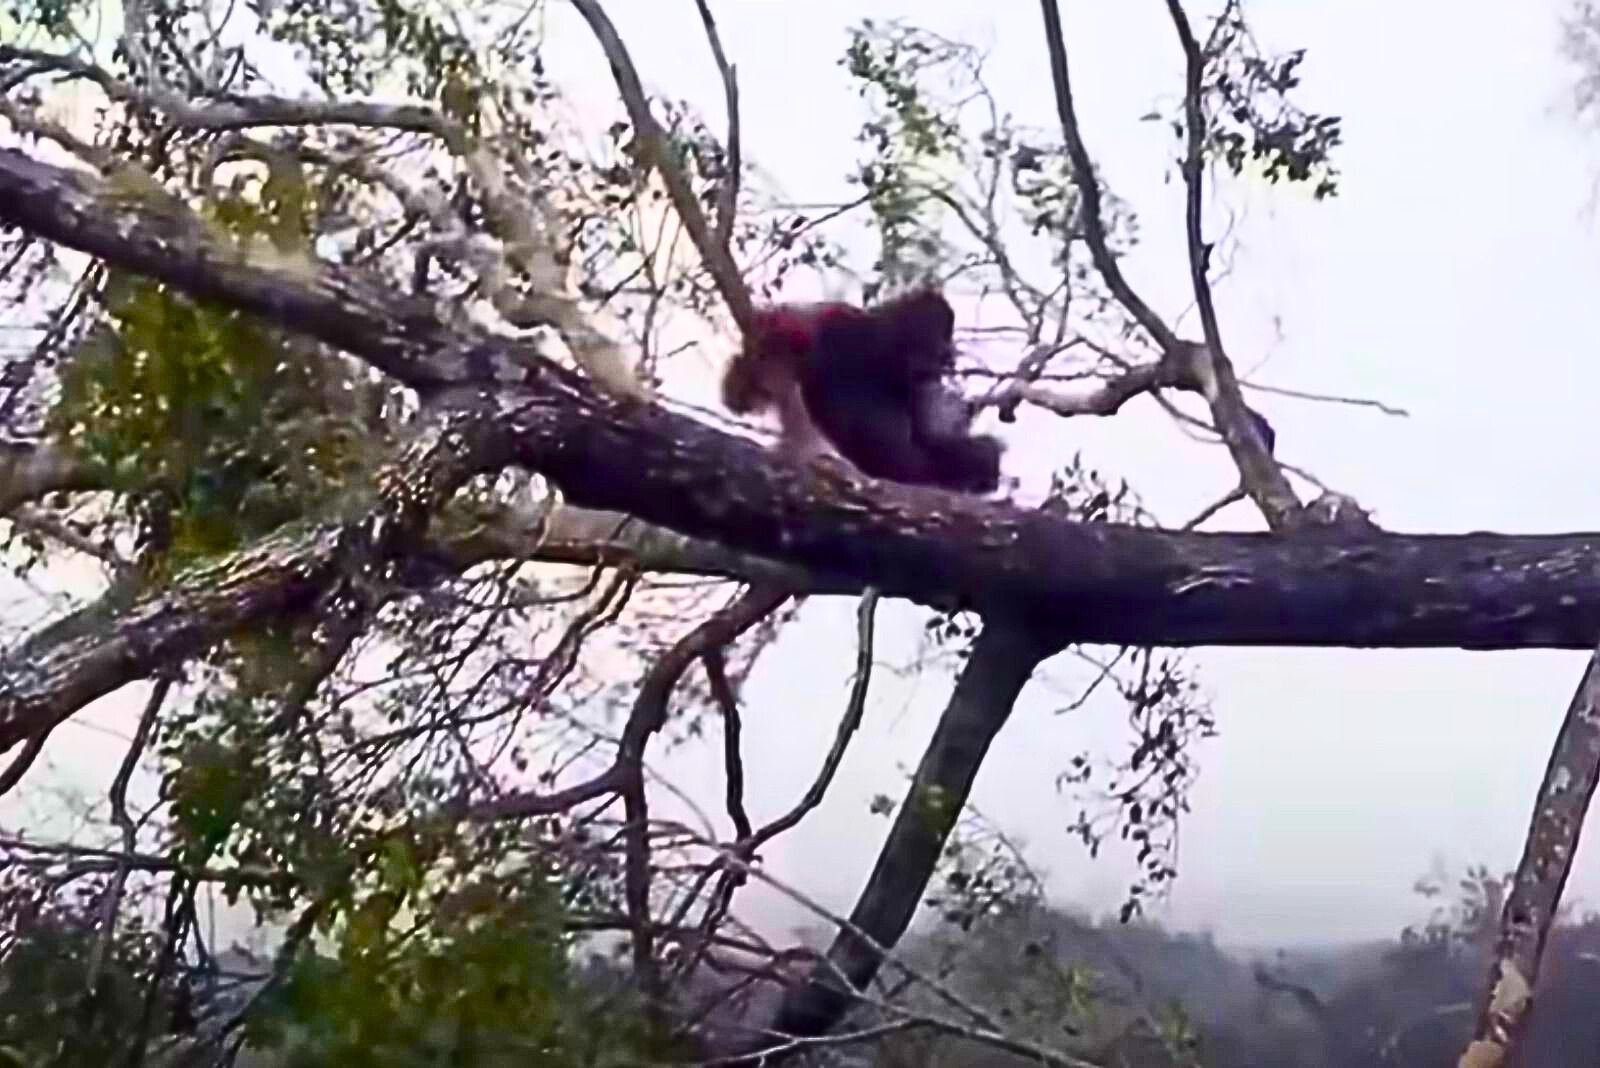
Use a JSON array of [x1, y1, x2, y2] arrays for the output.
[[722, 289, 1005, 494]]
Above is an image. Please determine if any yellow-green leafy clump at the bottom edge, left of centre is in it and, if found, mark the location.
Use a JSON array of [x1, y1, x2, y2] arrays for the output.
[[236, 833, 650, 1068]]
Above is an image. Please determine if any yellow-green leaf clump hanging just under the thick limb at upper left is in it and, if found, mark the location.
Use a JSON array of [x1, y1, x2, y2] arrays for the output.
[[51, 187, 379, 560]]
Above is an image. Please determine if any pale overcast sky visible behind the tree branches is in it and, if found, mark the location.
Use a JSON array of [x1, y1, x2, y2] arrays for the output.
[[9, 0, 1600, 945]]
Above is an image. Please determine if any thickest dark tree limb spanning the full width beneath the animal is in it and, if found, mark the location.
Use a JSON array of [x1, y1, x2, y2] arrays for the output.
[[0, 140, 1600, 668]]
